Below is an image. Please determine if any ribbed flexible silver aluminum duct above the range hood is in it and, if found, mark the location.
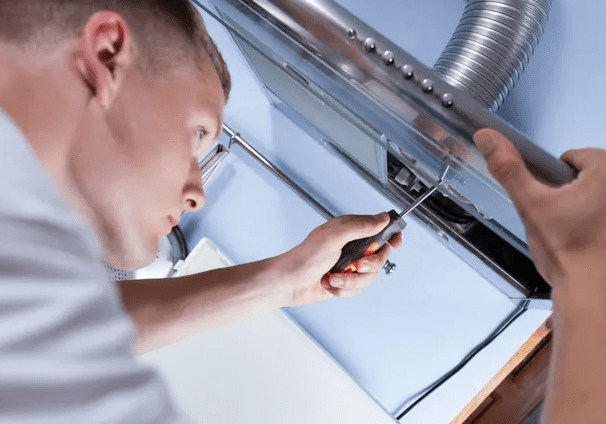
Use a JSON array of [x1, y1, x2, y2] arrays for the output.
[[434, 0, 551, 111]]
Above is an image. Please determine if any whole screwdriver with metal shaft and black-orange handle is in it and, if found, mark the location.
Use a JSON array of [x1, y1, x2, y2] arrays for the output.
[[328, 166, 449, 274]]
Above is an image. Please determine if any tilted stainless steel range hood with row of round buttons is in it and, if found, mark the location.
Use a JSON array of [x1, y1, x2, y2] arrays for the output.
[[204, 0, 573, 307]]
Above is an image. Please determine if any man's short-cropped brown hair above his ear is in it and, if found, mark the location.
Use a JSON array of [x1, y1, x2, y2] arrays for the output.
[[0, 0, 231, 99]]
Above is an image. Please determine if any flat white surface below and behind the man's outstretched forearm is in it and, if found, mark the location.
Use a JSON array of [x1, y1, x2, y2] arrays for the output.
[[141, 238, 396, 424]]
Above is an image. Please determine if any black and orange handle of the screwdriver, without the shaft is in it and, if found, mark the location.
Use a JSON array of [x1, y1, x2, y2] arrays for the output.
[[328, 210, 406, 274]]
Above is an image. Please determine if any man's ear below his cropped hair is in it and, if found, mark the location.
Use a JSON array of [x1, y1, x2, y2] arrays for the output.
[[74, 12, 133, 108]]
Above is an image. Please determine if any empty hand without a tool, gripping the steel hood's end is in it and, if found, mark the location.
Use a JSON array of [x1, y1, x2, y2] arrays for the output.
[[474, 129, 606, 287]]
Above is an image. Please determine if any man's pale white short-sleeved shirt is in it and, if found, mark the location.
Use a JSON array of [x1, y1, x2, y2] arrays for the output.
[[0, 111, 195, 424]]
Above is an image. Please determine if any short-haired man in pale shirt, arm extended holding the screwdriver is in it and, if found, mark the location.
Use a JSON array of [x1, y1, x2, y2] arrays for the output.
[[0, 0, 401, 424]]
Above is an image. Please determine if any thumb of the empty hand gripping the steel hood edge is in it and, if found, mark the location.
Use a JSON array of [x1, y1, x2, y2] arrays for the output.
[[473, 129, 536, 204]]
